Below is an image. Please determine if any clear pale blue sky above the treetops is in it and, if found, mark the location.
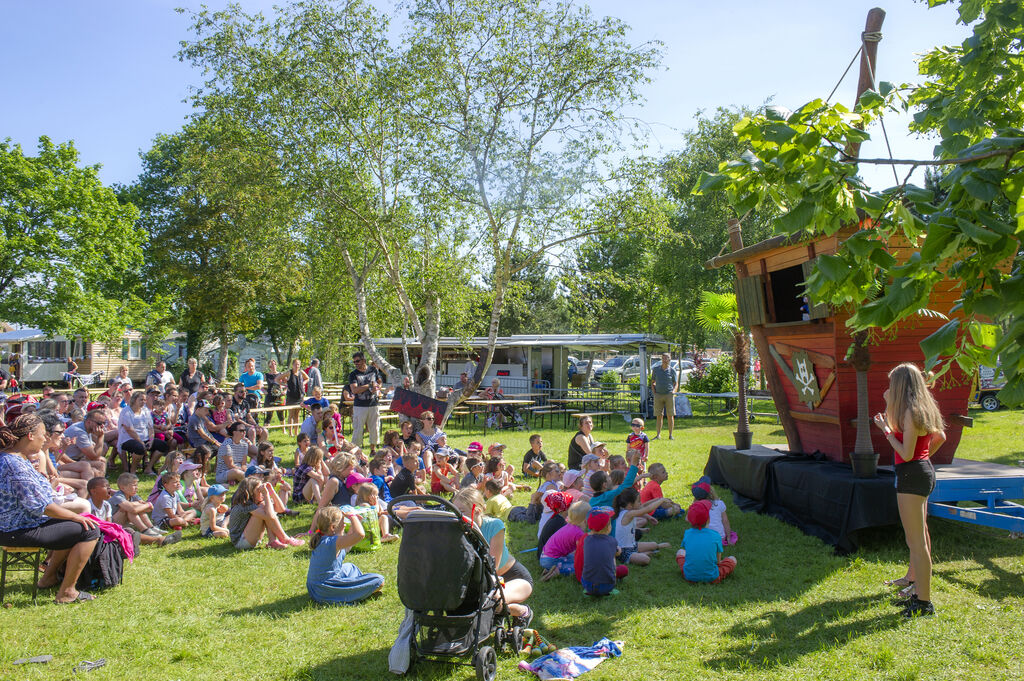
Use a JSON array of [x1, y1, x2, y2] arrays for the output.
[[0, 0, 968, 187]]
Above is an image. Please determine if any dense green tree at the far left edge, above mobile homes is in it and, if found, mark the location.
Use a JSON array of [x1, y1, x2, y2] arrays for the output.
[[0, 137, 151, 340]]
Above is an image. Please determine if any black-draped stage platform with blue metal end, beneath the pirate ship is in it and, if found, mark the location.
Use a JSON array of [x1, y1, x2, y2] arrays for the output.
[[705, 444, 1024, 553]]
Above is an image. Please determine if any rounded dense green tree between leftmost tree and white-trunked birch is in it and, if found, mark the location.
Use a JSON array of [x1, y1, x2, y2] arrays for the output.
[[123, 116, 303, 379]]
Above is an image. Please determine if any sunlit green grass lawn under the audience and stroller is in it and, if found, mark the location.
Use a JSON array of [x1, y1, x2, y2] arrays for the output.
[[0, 410, 1024, 681]]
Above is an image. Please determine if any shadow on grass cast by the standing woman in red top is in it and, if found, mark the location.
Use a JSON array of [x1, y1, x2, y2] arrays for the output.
[[705, 596, 903, 671]]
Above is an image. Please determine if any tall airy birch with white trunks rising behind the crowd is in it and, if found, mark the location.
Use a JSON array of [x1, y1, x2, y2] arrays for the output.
[[182, 0, 656, 409]]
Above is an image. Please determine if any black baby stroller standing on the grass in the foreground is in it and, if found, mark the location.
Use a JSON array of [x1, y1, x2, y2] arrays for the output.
[[387, 495, 522, 681]]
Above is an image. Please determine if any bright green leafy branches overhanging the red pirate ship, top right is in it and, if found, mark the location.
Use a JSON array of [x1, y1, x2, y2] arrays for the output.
[[696, 0, 1024, 405]]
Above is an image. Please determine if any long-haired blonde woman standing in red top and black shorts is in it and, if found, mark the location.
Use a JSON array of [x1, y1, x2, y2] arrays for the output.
[[874, 364, 946, 618]]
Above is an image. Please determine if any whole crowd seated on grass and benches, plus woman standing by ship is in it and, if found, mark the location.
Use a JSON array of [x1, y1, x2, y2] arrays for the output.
[[0, 353, 944, 614]]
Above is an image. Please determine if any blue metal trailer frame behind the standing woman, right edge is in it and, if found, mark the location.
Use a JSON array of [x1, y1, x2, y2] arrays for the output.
[[928, 459, 1024, 538]]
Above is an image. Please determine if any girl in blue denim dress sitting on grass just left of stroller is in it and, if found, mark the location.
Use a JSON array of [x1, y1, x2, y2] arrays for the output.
[[306, 506, 384, 604]]
